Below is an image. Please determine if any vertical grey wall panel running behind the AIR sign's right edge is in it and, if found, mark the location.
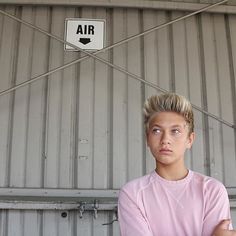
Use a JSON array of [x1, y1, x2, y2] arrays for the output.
[[93, 8, 111, 189]]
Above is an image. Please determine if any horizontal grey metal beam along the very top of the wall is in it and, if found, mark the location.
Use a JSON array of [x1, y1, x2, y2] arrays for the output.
[[0, 0, 236, 14]]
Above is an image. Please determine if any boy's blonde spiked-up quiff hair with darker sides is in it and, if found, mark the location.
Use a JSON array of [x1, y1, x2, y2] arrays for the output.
[[143, 93, 194, 134]]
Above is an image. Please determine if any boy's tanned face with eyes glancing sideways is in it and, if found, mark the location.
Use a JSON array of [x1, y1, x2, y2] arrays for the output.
[[147, 112, 194, 166]]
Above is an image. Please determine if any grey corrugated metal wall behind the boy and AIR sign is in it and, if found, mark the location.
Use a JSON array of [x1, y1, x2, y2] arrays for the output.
[[0, 2, 236, 236]]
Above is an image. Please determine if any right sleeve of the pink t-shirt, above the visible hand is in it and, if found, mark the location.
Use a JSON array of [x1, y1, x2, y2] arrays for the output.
[[202, 185, 232, 236]]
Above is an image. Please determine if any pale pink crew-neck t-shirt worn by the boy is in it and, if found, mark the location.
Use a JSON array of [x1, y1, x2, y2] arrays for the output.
[[118, 170, 232, 236]]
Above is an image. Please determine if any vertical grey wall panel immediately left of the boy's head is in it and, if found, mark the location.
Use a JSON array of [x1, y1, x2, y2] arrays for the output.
[[127, 9, 144, 183]]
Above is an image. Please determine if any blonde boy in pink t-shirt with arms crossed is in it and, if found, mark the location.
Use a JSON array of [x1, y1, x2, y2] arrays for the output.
[[118, 93, 236, 236]]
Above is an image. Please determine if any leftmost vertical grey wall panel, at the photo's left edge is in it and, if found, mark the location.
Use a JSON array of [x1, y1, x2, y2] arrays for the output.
[[0, 7, 17, 186]]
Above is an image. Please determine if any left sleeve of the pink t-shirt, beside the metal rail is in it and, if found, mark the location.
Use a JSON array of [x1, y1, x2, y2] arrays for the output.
[[118, 187, 153, 236]]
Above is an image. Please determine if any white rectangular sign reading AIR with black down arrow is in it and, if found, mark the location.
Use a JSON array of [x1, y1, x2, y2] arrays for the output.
[[65, 18, 105, 51]]
